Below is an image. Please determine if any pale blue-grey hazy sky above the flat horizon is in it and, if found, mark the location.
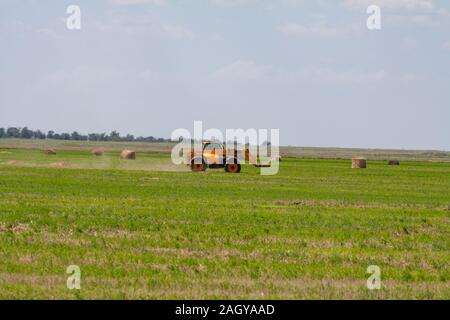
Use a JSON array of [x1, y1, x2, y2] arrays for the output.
[[0, 0, 450, 150]]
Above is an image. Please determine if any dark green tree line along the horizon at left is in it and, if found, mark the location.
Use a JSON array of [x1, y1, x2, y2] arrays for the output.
[[0, 127, 171, 142]]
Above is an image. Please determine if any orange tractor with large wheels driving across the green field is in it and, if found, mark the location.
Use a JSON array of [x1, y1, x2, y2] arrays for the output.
[[188, 141, 249, 173]]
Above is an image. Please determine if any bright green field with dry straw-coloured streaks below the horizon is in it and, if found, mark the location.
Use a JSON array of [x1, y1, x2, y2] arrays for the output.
[[0, 148, 450, 299]]
